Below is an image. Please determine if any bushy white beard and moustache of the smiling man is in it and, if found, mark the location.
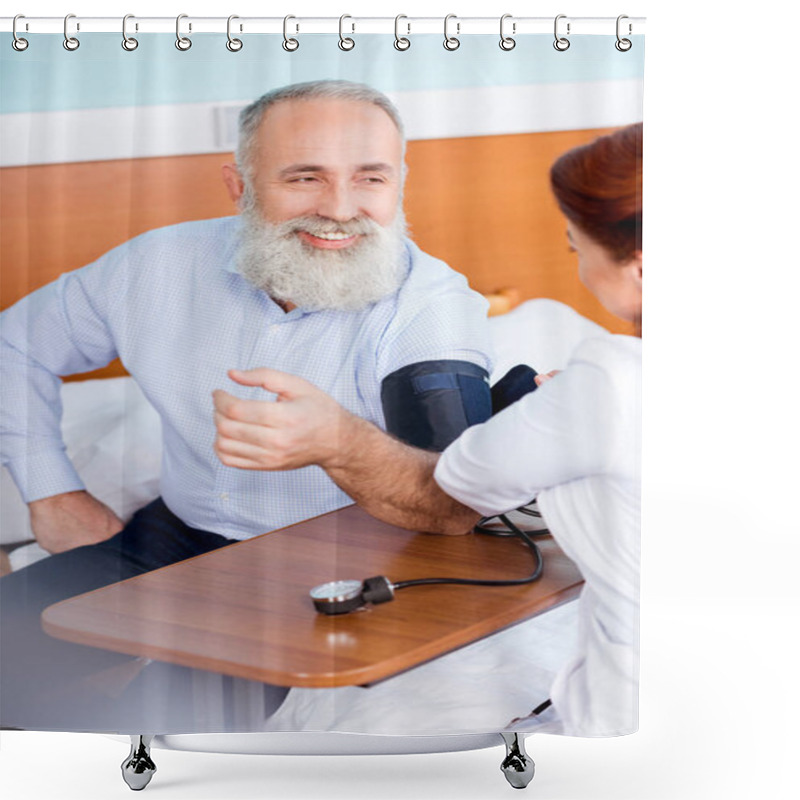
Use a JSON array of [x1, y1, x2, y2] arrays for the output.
[[237, 192, 406, 311]]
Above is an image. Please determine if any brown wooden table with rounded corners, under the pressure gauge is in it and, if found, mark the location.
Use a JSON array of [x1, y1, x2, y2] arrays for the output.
[[42, 506, 582, 687]]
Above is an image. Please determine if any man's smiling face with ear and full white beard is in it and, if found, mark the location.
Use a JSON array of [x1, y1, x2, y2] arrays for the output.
[[227, 97, 406, 310]]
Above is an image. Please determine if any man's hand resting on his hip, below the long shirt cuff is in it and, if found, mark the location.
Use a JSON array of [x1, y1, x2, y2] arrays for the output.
[[28, 492, 124, 553]]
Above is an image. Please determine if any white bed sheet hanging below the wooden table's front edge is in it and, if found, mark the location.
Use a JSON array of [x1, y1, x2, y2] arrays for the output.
[[264, 589, 578, 736]]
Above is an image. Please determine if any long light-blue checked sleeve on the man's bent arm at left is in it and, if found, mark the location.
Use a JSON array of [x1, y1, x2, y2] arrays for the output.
[[0, 251, 120, 502]]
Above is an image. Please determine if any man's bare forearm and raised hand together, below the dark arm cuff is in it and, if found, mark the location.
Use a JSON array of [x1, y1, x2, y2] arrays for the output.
[[214, 368, 478, 534]]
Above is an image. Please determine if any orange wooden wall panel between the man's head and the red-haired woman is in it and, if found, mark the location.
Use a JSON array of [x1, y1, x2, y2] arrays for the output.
[[406, 130, 632, 333]]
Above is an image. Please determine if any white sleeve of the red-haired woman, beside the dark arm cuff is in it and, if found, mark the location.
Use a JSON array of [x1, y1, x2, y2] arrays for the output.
[[434, 340, 619, 516]]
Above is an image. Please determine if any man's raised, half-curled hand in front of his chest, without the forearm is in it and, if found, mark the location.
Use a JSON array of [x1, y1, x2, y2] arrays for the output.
[[214, 367, 358, 470]]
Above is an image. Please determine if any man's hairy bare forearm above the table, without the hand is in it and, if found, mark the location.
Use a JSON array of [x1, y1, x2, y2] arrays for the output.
[[323, 414, 479, 534]]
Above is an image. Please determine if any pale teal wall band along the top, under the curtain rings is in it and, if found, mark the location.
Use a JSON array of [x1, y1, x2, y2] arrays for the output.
[[0, 33, 644, 114]]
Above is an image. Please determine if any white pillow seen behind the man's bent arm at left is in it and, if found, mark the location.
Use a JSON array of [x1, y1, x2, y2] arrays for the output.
[[0, 378, 161, 545]]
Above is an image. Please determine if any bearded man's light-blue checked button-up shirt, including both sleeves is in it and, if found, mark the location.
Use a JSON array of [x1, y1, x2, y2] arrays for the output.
[[0, 217, 491, 539]]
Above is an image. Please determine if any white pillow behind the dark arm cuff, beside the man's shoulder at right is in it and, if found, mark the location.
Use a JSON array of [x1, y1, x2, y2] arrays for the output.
[[489, 298, 609, 383]]
